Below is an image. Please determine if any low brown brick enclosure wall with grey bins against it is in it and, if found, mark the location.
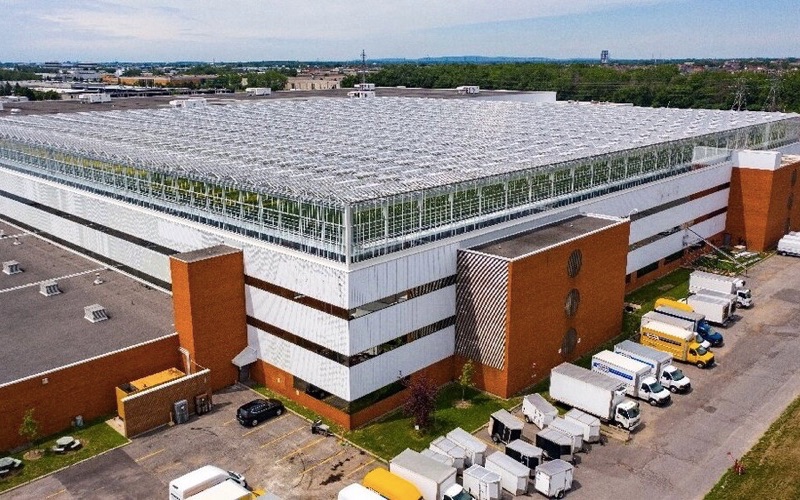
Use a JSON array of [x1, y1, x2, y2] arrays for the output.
[[121, 370, 211, 437]]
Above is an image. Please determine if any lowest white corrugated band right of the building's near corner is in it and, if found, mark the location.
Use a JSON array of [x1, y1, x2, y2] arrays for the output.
[[352, 326, 455, 399]]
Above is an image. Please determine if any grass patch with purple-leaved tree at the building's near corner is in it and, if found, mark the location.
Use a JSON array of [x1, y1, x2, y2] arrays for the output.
[[345, 384, 521, 460]]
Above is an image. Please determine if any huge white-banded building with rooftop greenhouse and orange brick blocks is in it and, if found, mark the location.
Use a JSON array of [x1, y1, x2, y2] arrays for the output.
[[0, 93, 800, 442]]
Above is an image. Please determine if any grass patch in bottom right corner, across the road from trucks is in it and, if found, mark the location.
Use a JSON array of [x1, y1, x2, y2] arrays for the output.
[[706, 398, 800, 500]]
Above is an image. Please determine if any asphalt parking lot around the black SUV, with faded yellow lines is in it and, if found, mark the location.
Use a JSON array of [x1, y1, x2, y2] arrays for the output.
[[4, 386, 381, 500]]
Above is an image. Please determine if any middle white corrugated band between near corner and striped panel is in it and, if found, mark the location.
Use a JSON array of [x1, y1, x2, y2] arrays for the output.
[[349, 285, 456, 354]]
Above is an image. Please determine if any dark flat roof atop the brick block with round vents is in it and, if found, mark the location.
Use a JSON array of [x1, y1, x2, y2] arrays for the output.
[[471, 215, 620, 260]]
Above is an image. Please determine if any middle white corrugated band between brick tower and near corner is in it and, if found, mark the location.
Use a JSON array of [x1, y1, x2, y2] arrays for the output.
[[244, 285, 350, 355]]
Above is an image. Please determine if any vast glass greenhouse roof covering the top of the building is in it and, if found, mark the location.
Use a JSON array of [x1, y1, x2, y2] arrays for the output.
[[0, 94, 800, 205]]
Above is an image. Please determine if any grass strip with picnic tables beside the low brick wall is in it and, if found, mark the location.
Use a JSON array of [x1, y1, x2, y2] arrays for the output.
[[0, 420, 128, 492]]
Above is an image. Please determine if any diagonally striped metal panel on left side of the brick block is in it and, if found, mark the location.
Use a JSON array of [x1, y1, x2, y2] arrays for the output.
[[456, 251, 508, 370]]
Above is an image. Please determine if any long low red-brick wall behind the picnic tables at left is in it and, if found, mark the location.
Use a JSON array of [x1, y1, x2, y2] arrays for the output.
[[0, 335, 181, 450]]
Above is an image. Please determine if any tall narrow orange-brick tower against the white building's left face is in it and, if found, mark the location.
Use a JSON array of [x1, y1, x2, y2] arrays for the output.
[[170, 251, 247, 391]]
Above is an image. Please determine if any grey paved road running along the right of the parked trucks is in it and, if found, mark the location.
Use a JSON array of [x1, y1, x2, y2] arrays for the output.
[[568, 257, 800, 500]]
